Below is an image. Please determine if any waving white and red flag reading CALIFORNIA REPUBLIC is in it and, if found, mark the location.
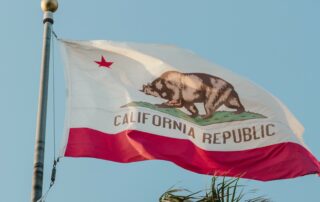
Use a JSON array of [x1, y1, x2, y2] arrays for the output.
[[61, 41, 320, 181]]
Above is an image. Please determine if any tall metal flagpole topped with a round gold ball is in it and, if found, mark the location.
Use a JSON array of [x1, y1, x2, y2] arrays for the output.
[[31, 0, 58, 202]]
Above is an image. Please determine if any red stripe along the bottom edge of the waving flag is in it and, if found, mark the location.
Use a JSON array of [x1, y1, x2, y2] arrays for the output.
[[65, 128, 320, 181]]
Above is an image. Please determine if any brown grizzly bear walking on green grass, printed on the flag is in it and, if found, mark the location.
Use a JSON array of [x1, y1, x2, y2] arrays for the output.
[[140, 71, 245, 119]]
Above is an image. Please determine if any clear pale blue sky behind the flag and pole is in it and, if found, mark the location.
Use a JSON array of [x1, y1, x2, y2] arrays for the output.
[[0, 0, 320, 202]]
